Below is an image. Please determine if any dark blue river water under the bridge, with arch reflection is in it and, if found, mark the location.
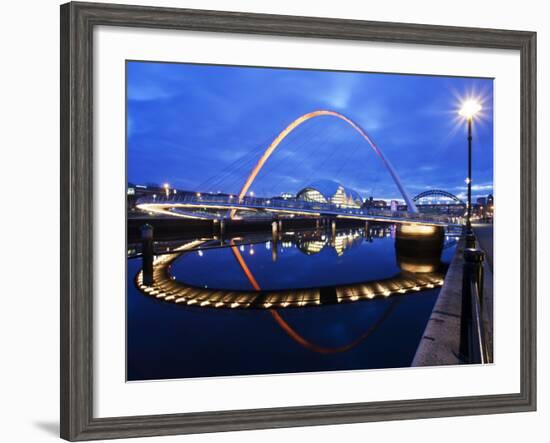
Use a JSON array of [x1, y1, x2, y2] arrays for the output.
[[127, 225, 456, 381]]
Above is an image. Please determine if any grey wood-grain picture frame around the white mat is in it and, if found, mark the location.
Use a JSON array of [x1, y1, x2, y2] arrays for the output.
[[61, 3, 536, 441]]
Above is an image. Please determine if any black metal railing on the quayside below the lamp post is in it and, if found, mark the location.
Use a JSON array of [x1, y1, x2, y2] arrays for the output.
[[460, 248, 489, 364]]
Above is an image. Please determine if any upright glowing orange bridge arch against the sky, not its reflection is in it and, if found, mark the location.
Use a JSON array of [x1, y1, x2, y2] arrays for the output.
[[230, 110, 418, 218]]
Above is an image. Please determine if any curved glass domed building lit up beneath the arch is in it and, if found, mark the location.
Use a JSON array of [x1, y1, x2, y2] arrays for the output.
[[296, 180, 363, 208]]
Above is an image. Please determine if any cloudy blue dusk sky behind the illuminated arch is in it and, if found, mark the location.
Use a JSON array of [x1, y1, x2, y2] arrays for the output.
[[127, 62, 493, 201]]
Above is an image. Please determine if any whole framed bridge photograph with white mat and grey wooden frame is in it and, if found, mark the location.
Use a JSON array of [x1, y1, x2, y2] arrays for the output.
[[61, 3, 536, 441]]
